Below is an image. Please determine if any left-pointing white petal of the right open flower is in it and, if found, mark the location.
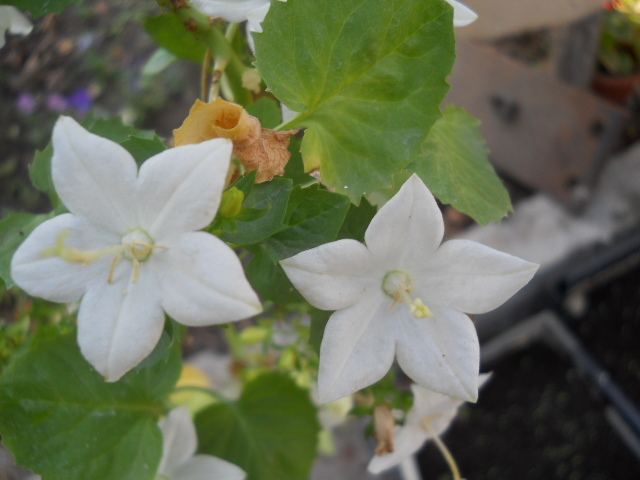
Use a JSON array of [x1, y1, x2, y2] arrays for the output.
[[280, 239, 382, 310]]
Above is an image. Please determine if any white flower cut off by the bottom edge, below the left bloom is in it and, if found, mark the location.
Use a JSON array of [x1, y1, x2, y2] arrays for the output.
[[156, 407, 246, 480]]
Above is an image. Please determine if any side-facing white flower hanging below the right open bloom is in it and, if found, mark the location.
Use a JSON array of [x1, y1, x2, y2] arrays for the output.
[[368, 374, 489, 473]]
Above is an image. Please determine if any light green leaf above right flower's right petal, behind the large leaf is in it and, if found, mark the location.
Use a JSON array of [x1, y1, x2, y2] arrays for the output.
[[408, 106, 513, 225]]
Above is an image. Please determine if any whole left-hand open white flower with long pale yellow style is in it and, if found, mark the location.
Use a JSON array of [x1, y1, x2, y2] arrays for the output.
[[11, 117, 262, 381]]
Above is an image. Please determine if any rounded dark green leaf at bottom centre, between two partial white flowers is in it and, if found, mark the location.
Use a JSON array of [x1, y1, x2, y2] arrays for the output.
[[196, 373, 320, 480]]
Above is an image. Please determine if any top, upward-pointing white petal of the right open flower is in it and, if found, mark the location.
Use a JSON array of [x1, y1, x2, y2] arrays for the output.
[[365, 174, 444, 269]]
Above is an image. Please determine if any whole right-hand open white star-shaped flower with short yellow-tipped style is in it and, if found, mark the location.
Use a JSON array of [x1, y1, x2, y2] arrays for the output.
[[281, 175, 538, 403]]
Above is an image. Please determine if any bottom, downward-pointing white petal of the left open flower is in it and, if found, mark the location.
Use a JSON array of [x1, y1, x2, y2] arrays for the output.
[[78, 259, 164, 382]]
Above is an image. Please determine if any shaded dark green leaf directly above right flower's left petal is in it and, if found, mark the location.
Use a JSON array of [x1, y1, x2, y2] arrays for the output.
[[264, 184, 350, 260]]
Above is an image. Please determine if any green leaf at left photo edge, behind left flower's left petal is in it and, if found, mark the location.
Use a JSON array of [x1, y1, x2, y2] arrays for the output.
[[0, 213, 53, 289]]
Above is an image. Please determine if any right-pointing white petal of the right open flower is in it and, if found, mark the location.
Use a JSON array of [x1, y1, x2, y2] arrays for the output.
[[414, 240, 538, 313]]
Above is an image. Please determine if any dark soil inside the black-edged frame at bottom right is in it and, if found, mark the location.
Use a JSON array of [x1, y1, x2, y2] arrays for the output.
[[420, 345, 640, 480]]
